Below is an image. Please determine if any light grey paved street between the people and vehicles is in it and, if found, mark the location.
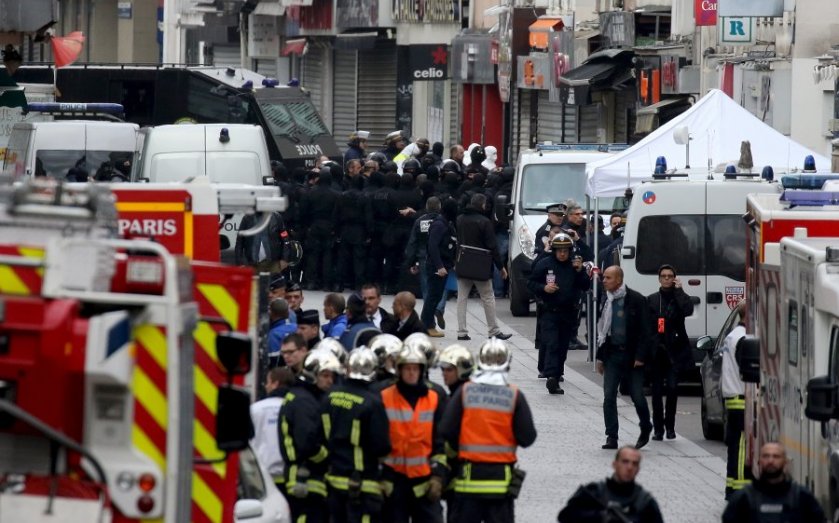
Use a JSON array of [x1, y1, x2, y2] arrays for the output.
[[303, 292, 725, 523]]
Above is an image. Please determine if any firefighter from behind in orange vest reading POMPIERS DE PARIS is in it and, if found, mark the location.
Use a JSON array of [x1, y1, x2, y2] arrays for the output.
[[440, 338, 536, 523]]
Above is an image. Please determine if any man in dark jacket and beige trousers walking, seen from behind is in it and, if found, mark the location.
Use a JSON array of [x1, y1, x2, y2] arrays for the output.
[[457, 194, 512, 340]]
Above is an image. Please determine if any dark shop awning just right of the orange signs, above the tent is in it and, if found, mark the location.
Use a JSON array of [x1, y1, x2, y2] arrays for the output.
[[559, 49, 634, 105]]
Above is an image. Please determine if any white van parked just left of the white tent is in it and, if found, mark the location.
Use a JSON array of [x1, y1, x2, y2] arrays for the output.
[[507, 144, 627, 316]]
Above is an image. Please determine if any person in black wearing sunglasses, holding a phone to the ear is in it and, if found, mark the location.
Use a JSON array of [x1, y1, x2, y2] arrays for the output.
[[647, 265, 693, 441]]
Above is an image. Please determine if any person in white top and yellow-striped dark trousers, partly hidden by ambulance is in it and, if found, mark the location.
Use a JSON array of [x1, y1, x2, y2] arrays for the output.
[[720, 300, 751, 500]]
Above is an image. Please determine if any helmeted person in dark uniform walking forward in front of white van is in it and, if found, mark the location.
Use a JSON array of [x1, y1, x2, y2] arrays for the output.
[[527, 233, 588, 394]]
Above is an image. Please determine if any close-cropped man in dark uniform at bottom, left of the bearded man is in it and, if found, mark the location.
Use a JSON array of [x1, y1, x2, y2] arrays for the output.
[[556, 446, 664, 523]]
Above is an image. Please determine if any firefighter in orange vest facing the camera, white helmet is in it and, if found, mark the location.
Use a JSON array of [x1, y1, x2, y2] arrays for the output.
[[382, 347, 448, 523]]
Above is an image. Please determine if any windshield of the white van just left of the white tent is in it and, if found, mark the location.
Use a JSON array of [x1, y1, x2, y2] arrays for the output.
[[519, 163, 586, 215]]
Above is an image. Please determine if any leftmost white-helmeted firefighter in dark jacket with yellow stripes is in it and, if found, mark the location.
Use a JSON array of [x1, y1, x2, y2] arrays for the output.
[[278, 351, 342, 523]]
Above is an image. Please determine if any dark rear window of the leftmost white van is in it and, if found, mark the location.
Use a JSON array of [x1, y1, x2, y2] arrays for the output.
[[34, 149, 134, 181]]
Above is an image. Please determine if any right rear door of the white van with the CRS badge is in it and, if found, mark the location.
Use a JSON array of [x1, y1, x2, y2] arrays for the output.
[[702, 182, 748, 340]]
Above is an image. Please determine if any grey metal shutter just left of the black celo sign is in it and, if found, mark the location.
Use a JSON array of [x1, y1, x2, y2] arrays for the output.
[[358, 42, 396, 147]]
